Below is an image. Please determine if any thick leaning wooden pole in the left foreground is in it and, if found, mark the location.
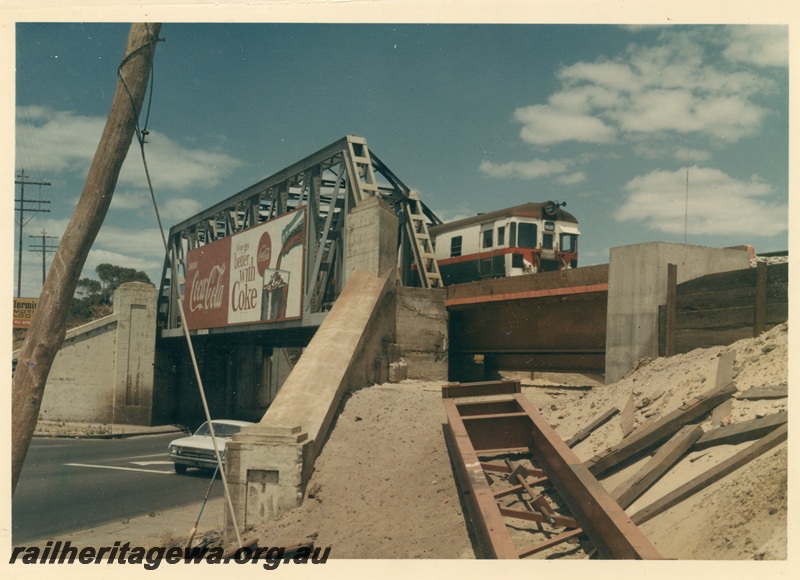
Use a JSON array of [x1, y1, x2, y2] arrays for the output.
[[11, 23, 161, 494]]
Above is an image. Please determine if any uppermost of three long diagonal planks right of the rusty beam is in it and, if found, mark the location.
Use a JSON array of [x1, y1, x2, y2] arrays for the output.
[[585, 384, 736, 477]]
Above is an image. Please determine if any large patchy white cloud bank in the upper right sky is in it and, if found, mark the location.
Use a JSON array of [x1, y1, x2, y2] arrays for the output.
[[506, 27, 787, 150]]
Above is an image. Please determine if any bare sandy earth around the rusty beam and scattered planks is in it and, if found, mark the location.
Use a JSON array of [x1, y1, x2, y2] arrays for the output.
[[220, 324, 788, 560]]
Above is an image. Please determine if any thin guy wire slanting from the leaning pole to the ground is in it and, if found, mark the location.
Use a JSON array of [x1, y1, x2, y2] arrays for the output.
[[117, 24, 243, 548]]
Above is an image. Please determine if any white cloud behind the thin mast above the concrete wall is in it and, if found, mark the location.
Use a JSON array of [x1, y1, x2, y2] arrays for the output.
[[616, 166, 788, 237]]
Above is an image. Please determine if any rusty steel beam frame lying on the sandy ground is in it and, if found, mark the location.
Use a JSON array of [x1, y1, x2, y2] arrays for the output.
[[443, 383, 661, 559]]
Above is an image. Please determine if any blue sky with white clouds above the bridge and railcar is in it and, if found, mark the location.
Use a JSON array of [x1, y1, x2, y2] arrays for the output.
[[9, 22, 789, 296]]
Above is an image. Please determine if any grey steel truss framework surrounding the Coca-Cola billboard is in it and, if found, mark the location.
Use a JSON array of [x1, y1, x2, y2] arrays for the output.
[[158, 135, 442, 338]]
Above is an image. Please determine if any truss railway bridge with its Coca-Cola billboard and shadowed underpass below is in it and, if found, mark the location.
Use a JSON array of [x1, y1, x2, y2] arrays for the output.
[[153, 136, 442, 424]]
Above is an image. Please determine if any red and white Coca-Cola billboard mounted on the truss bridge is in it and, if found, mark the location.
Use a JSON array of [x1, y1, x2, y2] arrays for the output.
[[184, 207, 306, 330]]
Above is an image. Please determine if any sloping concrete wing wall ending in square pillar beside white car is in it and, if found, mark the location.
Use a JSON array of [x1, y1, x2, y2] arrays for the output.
[[225, 269, 395, 526]]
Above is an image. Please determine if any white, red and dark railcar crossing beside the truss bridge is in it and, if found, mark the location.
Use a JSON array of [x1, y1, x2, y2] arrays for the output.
[[430, 201, 580, 285]]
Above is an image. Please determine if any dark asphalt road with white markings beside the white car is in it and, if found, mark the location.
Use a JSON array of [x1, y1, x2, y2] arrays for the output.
[[12, 433, 222, 545]]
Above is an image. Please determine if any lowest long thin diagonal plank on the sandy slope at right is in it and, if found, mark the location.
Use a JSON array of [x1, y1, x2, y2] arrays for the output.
[[631, 424, 789, 526]]
